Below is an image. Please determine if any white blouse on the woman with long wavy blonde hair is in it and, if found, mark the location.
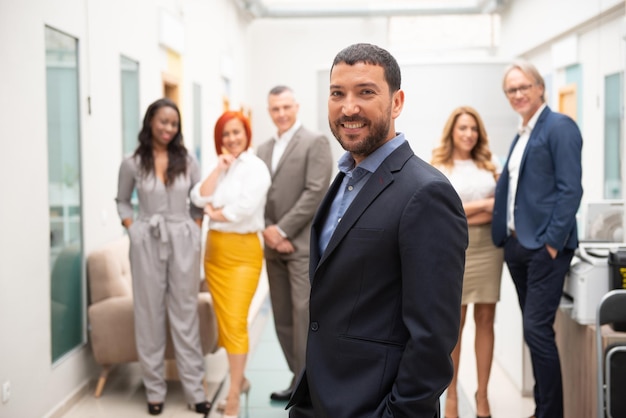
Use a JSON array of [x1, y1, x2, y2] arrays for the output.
[[438, 159, 502, 203]]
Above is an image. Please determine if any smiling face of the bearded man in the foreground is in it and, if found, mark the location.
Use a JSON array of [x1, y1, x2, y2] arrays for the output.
[[328, 62, 404, 164]]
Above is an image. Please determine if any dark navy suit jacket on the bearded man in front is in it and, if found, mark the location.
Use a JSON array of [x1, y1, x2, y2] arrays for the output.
[[290, 143, 468, 418]]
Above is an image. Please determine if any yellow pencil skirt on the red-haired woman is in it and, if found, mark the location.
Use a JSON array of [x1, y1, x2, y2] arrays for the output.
[[204, 230, 263, 354]]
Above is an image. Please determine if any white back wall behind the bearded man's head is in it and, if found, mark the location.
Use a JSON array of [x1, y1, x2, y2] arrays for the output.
[[241, 18, 515, 165]]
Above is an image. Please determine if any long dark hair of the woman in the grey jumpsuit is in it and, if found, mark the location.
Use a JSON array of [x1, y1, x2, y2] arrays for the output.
[[134, 98, 187, 186]]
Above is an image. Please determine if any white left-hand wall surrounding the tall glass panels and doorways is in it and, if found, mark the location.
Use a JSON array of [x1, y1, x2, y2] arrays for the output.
[[0, 0, 247, 418]]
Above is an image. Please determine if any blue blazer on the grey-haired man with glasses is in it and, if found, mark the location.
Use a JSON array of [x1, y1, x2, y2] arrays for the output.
[[491, 106, 583, 251]]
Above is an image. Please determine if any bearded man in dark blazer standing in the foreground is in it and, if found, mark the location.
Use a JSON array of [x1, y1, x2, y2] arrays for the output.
[[289, 44, 467, 418]]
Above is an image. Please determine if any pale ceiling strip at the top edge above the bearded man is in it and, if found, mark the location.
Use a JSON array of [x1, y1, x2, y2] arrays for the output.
[[233, 0, 512, 18]]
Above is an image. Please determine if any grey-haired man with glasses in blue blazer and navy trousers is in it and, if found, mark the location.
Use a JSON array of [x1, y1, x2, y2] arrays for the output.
[[492, 61, 583, 418]]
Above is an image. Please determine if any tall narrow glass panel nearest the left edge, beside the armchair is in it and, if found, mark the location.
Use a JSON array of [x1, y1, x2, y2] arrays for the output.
[[45, 27, 84, 362]]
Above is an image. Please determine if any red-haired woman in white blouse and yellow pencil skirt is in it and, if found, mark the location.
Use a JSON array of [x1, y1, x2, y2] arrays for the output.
[[191, 111, 271, 417]]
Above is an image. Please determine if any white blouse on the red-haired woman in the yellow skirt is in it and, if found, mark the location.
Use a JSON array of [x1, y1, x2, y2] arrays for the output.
[[189, 150, 271, 234]]
